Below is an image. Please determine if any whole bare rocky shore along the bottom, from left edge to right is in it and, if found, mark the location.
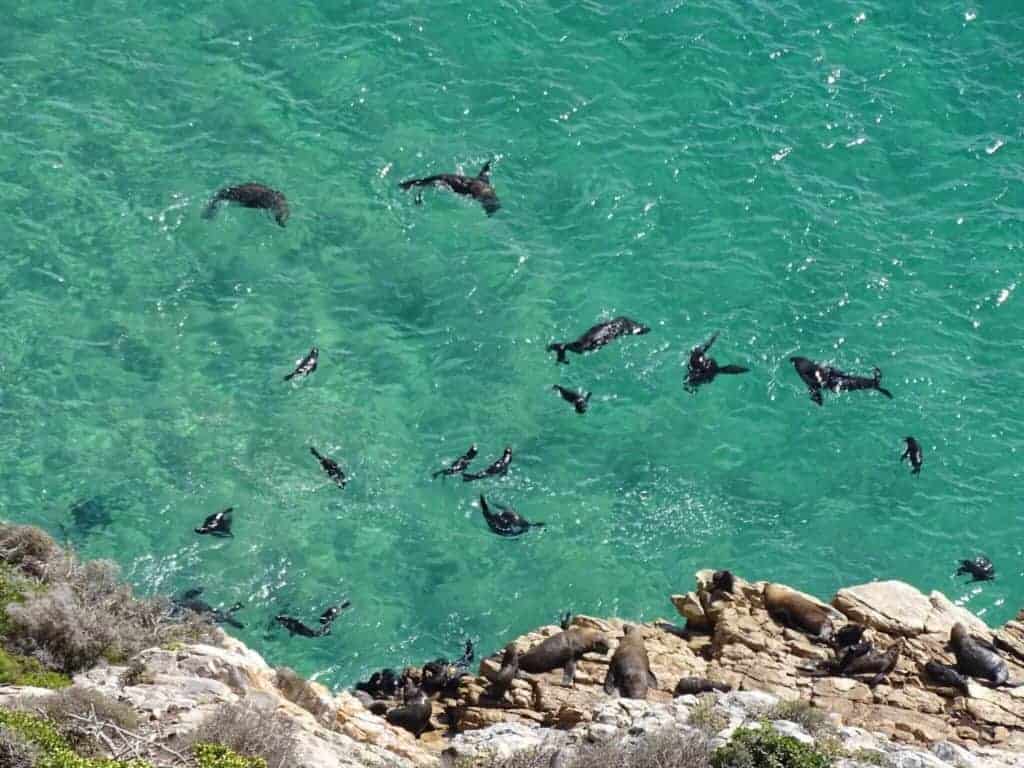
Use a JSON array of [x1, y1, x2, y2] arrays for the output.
[[0, 570, 1024, 768]]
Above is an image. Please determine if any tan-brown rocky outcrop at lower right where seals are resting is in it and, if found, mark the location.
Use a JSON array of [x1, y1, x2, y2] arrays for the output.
[[425, 571, 1024, 751]]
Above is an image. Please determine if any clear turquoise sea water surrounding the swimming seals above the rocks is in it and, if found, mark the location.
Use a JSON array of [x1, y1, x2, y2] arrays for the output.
[[0, 0, 1024, 685]]
